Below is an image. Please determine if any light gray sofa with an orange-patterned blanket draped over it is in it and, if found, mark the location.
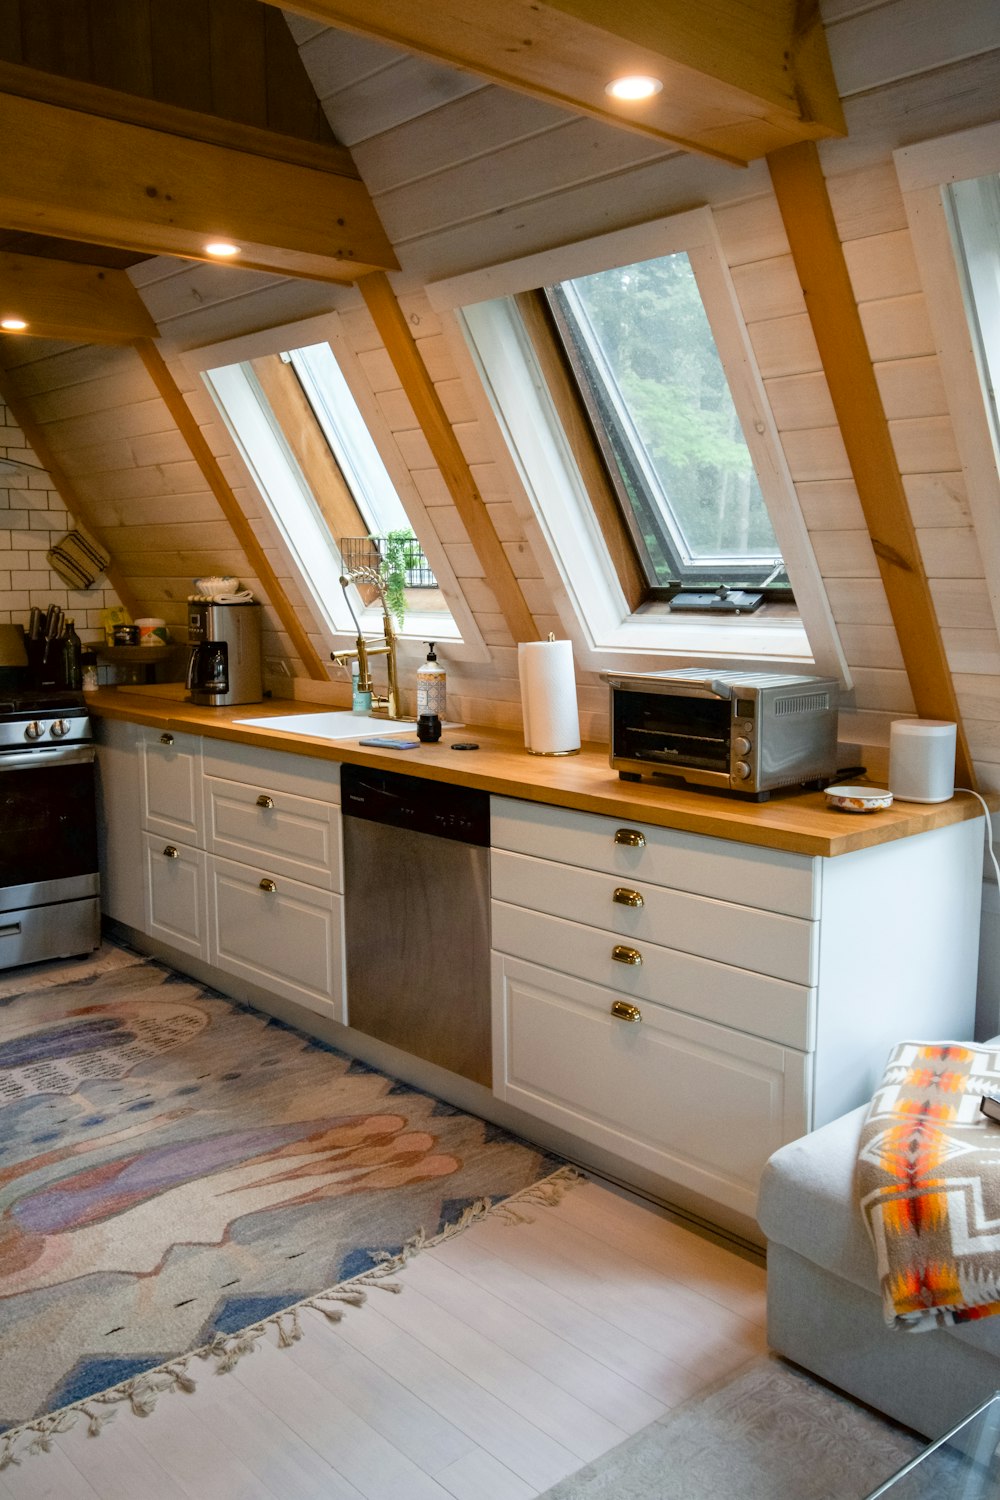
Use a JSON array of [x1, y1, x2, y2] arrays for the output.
[[757, 1106, 1000, 1437]]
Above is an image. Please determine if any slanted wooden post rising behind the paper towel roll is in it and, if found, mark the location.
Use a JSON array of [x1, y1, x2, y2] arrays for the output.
[[358, 272, 538, 641]]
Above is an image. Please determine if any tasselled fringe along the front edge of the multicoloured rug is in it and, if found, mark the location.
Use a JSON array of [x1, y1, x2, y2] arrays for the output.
[[0, 1166, 585, 1472]]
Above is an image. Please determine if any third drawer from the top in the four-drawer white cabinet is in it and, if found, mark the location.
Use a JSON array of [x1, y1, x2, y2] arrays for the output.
[[492, 902, 816, 1052]]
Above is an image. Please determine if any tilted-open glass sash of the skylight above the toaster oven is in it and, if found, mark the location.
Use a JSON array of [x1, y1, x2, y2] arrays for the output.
[[547, 252, 781, 590]]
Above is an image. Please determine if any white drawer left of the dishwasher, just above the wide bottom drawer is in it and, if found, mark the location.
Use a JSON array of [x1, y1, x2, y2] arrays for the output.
[[205, 776, 340, 891]]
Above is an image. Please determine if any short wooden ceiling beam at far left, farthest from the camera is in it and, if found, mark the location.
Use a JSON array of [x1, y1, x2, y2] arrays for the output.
[[0, 251, 157, 344]]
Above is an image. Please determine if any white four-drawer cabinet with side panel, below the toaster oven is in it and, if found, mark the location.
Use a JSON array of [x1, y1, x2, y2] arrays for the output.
[[492, 798, 982, 1215]]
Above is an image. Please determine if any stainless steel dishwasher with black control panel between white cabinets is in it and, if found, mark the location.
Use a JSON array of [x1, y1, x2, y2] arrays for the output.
[[340, 765, 492, 1088]]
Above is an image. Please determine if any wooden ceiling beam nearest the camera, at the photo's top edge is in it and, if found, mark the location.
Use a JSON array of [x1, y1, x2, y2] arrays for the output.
[[265, 0, 847, 165]]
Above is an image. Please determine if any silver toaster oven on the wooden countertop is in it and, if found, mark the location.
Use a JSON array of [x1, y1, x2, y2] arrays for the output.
[[601, 668, 840, 801]]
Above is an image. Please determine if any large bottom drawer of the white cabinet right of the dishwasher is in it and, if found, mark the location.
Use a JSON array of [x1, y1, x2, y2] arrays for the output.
[[493, 954, 810, 1217]]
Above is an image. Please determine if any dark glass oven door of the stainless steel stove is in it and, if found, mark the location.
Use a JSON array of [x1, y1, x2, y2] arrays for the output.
[[0, 746, 99, 912]]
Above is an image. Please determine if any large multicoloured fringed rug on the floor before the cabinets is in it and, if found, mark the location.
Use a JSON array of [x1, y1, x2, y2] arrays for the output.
[[0, 948, 574, 1466]]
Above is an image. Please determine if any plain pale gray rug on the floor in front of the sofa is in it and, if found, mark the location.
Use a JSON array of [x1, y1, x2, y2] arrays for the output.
[[541, 1355, 923, 1500]]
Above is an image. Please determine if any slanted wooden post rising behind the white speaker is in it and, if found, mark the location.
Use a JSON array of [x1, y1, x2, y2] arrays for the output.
[[768, 141, 976, 788]]
